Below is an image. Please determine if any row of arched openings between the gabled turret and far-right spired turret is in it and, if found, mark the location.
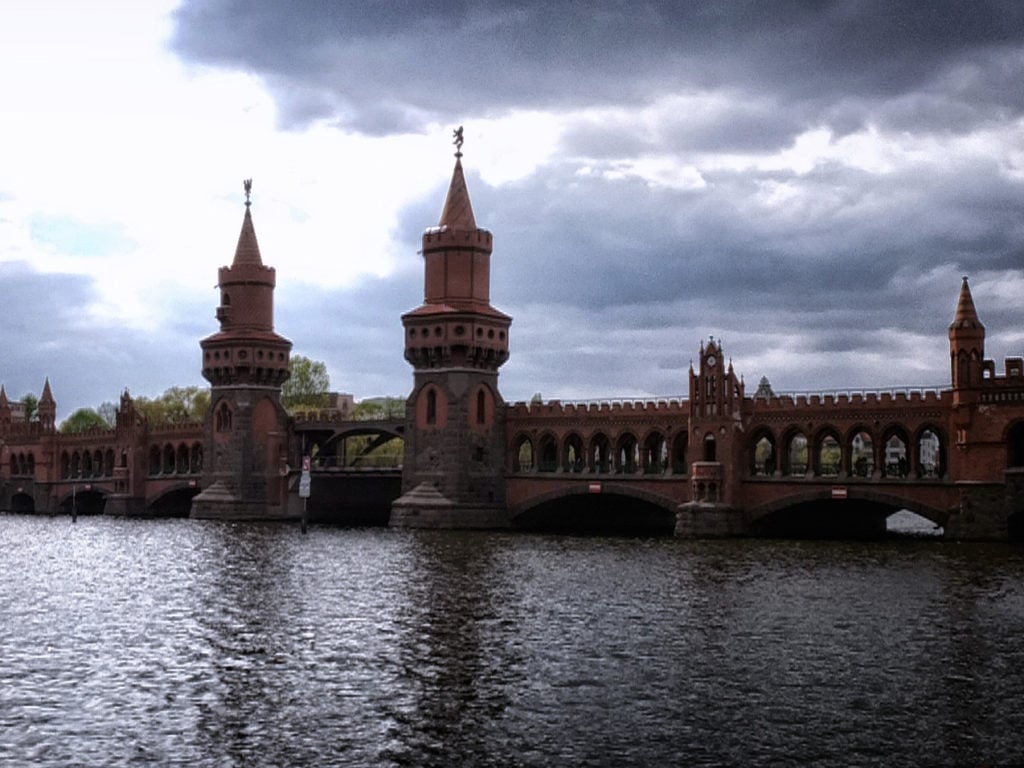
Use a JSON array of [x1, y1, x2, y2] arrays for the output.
[[749, 426, 947, 479]]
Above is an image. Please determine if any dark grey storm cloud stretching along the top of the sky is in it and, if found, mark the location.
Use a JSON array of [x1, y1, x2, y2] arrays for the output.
[[172, 0, 1024, 138]]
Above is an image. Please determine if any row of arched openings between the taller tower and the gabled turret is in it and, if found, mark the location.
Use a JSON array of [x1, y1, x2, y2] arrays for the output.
[[511, 430, 687, 475]]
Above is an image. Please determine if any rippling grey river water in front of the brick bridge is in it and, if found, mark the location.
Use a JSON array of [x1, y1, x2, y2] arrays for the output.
[[0, 515, 1024, 768]]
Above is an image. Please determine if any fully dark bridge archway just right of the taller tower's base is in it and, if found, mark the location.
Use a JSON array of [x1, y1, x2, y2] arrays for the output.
[[511, 487, 679, 536]]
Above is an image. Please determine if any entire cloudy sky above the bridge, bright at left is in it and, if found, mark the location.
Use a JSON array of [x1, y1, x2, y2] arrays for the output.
[[0, 0, 1024, 418]]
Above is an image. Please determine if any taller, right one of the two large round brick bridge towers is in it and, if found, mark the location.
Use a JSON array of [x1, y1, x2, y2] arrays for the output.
[[391, 128, 512, 528]]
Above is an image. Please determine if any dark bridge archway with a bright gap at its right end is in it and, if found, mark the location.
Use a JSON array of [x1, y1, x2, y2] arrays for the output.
[[750, 486, 948, 539]]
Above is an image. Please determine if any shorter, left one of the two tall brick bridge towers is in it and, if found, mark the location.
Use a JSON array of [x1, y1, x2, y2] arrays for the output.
[[191, 179, 292, 520]]
